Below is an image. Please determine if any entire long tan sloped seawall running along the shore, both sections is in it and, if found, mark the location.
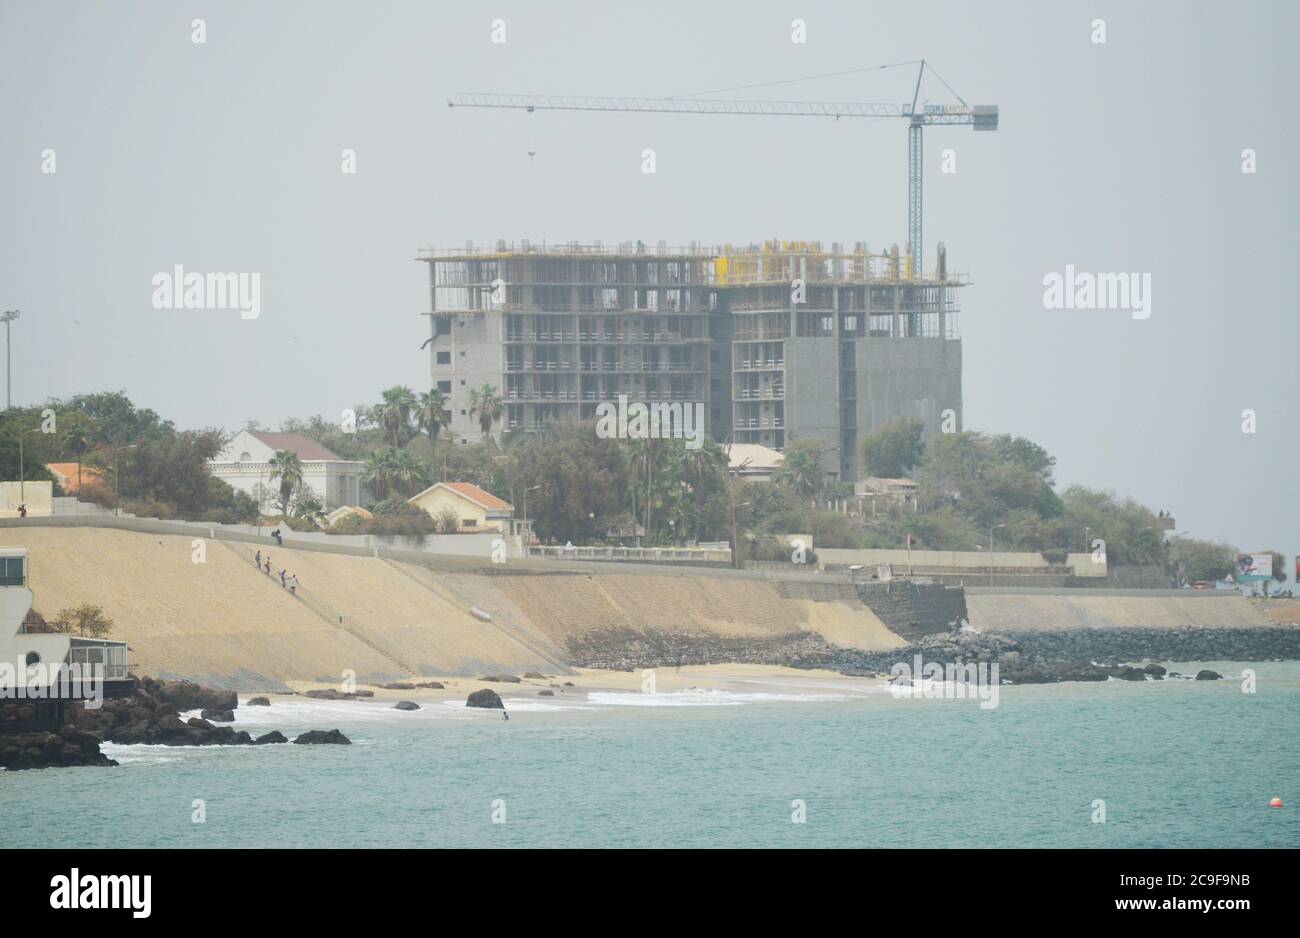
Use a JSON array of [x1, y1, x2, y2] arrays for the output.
[[0, 525, 1300, 690]]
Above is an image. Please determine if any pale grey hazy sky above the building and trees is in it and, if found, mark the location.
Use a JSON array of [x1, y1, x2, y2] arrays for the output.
[[0, 0, 1300, 555]]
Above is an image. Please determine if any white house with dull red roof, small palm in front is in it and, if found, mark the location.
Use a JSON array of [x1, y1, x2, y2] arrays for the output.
[[208, 430, 365, 511]]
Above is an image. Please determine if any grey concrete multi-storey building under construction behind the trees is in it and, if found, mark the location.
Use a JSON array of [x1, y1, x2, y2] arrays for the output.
[[417, 240, 967, 481]]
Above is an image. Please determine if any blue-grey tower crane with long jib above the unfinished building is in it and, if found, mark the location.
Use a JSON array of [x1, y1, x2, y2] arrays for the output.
[[447, 58, 997, 274]]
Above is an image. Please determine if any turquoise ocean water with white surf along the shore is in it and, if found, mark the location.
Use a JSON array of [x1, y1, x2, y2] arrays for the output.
[[0, 663, 1300, 848]]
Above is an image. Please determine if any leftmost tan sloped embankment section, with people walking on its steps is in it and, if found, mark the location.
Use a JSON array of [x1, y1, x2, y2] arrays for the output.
[[0, 527, 559, 690]]
